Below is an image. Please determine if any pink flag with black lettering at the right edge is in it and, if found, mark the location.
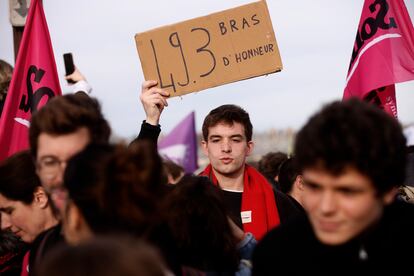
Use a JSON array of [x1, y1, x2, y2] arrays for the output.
[[343, 0, 414, 117]]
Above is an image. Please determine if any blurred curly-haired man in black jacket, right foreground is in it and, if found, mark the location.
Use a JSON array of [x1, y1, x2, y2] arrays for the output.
[[253, 99, 414, 275]]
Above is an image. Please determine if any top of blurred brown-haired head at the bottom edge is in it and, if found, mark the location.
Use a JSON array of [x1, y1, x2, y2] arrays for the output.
[[35, 235, 173, 276]]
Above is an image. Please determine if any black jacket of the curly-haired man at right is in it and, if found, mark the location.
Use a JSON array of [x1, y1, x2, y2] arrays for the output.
[[253, 201, 414, 276]]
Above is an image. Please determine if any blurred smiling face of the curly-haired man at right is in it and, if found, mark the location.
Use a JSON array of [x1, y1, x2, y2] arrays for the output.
[[303, 168, 394, 245]]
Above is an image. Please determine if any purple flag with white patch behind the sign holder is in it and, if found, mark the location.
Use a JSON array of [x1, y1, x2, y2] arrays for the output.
[[158, 111, 198, 173]]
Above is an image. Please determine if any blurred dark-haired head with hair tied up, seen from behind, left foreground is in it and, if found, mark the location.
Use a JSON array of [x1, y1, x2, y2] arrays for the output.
[[62, 141, 184, 275]]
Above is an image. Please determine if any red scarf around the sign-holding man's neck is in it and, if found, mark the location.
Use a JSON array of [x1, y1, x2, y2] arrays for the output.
[[200, 164, 280, 240]]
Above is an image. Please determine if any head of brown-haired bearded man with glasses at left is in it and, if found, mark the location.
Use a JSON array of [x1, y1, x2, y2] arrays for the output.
[[29, 92, 111, 213]]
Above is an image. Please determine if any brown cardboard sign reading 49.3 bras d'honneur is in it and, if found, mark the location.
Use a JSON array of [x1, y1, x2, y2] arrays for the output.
[[135, 1, 282, 96]]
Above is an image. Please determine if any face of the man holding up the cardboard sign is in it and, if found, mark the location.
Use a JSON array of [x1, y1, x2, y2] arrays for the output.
[[202, 122, 253, 177]]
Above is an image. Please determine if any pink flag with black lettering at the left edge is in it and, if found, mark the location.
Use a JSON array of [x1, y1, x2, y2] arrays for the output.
[[0, 0, 62, 160]]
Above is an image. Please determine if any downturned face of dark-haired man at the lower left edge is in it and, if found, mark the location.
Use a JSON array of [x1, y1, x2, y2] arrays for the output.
[[0, 194, 45, 243]]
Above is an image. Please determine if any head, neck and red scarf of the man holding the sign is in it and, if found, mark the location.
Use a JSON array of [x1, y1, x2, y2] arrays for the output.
[[201, 105, 280, 239]]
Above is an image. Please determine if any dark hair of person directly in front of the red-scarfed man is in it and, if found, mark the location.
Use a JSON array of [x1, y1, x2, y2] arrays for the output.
[[164, 175, 239, 271]]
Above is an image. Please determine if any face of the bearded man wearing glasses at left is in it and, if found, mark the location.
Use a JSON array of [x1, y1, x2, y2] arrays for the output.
[[36, 127, 90, 210]]
